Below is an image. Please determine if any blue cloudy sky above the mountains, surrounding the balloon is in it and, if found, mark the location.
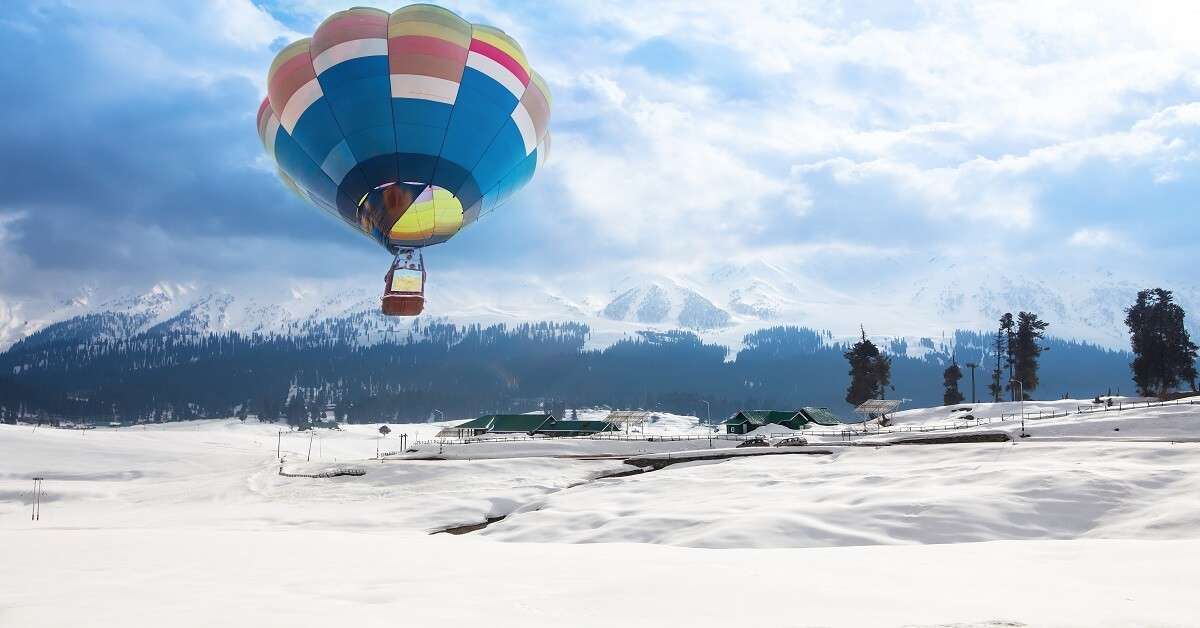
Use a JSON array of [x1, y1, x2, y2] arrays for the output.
[[0, 0, 1200, 309]]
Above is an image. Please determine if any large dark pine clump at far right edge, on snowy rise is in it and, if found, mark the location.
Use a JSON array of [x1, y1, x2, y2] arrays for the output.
[[1126, 288, 1198, 396]]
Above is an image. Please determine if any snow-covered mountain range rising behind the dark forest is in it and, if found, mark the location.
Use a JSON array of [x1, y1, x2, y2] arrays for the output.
[[0, 258, 1200, 349]]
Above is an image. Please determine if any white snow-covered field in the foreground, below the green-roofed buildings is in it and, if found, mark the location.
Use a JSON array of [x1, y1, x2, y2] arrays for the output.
[[0, 401, 1200, 627]]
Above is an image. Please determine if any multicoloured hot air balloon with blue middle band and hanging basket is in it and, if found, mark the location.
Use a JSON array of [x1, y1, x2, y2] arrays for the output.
[[258, 5, 551, 316]]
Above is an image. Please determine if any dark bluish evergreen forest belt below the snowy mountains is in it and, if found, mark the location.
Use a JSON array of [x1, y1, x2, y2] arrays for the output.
[[0, 315, 1128, 426]]
